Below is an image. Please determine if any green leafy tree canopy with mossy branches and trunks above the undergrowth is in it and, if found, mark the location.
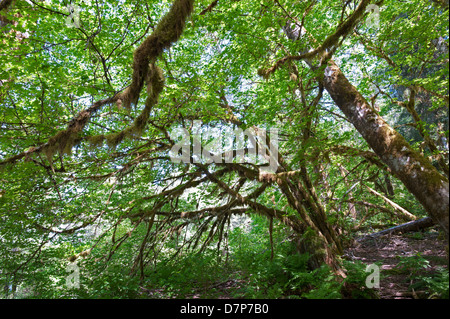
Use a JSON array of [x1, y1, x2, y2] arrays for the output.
[[0, 0, 449, 297]]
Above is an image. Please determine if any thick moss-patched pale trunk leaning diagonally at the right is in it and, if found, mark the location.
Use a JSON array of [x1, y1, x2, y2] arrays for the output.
[[323, 60, 449, 239]]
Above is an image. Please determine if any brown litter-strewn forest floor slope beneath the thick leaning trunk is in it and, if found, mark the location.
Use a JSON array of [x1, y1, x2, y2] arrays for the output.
[[346, 231, 449, 299]]
